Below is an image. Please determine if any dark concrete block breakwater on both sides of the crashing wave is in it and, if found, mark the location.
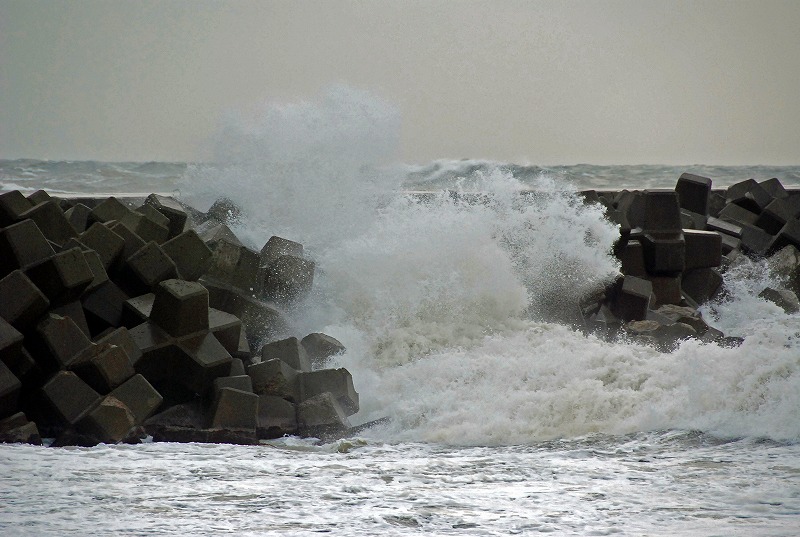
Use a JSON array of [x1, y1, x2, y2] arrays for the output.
[[0, 174, 800, 446]]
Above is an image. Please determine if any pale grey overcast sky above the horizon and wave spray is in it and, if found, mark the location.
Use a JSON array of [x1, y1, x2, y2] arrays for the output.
[[0, 0, 800, 165]]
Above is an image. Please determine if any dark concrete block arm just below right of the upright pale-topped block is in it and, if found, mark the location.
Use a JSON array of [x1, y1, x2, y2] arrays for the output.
[[173, 334, 228, 395]]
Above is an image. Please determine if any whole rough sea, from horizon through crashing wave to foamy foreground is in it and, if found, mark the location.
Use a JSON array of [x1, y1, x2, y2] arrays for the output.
[[0, 136, 800, 537]]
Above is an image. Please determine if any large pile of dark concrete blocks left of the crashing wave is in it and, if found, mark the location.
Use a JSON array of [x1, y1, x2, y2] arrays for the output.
[[0, 191, 346, 446]]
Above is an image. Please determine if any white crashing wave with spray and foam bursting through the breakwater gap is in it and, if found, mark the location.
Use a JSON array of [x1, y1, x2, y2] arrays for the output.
[[182, 87, 800, 445]]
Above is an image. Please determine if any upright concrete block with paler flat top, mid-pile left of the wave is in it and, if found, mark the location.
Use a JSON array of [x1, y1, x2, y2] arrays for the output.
[[150, 279, 208, 337]]
